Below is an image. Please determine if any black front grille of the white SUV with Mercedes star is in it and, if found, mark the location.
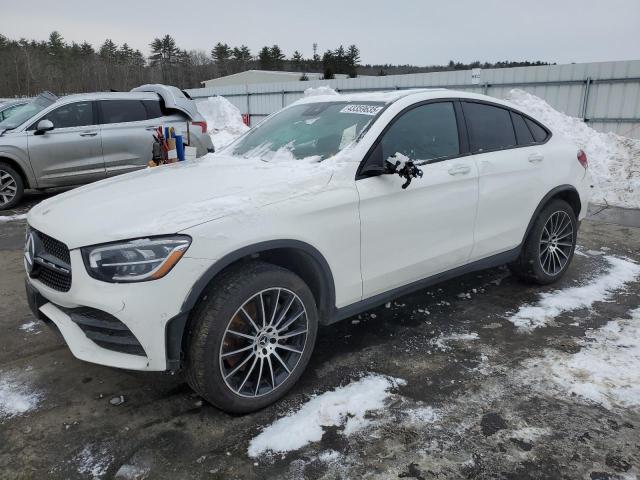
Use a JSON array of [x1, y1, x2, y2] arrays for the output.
[[30, 229, 71, 292]]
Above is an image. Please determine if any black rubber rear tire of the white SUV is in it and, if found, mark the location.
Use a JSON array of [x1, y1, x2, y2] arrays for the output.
[[509, 199, 578, 285]]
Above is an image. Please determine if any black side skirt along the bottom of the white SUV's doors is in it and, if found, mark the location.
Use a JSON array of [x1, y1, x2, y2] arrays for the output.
[[324, 245, 522, 325]]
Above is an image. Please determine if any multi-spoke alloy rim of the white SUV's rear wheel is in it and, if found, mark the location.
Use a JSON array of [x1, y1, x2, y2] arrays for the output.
[[540, 210, 573, 276]]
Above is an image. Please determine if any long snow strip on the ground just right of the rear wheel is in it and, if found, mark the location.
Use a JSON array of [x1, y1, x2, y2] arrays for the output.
[[507, 255, 640, 331]]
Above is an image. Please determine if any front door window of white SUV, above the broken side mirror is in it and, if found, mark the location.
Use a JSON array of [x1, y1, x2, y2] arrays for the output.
[[381, 102, 460, 161]]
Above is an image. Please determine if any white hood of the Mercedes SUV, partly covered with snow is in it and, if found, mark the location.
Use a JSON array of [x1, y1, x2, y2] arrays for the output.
[[27, 154, 332, 249]]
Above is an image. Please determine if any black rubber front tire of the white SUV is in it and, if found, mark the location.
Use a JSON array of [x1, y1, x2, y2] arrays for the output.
[[185, 261, 318, 413]]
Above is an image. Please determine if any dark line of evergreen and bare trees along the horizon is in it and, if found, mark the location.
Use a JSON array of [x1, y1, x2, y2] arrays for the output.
[[0, 31, 545, 97]]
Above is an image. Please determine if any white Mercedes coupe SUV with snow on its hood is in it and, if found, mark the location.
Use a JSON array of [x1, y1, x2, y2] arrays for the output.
[[24, 90, 590, 412]]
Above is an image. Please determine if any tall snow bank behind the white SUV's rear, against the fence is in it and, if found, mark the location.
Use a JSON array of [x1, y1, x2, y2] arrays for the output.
[[506, 89, 640, 208]]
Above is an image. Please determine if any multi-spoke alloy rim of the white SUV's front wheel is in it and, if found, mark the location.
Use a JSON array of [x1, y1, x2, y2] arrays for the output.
[[219, 287, 309, 398]]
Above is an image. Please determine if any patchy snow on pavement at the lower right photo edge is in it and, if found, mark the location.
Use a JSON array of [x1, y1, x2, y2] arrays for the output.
[[529, 308, 640, 409]]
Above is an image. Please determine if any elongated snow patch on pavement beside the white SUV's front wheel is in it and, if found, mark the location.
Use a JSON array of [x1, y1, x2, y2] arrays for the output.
[[248, 375, 405, 457]]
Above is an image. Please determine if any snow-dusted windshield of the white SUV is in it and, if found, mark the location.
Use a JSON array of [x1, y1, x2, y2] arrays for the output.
[[228, 102, 384, 161]]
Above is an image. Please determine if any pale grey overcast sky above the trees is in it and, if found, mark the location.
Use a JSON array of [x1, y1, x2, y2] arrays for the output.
[[0, 0, 640, 65]]
